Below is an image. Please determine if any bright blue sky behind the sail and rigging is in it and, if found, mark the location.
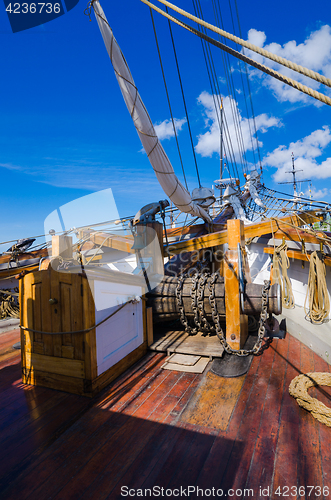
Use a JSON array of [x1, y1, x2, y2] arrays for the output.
[[0, 0, 331, 251]]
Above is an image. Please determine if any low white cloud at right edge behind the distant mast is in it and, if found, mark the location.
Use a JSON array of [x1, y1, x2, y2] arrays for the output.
[[263, 126, 331, 182]]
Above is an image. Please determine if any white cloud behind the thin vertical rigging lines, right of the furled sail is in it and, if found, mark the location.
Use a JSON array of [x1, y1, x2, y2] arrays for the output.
[[195, 92, 281, 158]]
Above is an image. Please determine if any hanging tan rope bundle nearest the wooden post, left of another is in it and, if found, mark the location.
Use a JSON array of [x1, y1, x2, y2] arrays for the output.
[[273, 243, 294, 309]]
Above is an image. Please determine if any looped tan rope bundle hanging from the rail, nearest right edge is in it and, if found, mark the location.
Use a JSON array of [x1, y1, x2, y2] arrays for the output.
[[304, 250, 330, 325]]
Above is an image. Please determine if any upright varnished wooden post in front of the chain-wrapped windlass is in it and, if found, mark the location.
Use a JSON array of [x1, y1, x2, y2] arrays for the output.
[[224, 219, 248, 349]]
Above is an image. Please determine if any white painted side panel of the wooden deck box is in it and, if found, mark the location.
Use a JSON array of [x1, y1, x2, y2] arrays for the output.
[[94, 281, 143, 375]]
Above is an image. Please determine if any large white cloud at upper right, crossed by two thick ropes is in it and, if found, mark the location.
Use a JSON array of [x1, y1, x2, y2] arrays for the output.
[[245, 25, 331, 106]]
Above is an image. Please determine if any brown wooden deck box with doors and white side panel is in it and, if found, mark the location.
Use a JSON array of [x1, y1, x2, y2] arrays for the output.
[[20, 267, 147, 396]]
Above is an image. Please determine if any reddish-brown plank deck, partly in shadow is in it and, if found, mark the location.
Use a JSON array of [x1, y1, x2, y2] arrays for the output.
[[0, 331, 331, 500]]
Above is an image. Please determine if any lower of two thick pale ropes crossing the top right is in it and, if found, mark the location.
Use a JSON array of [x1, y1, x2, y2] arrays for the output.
[[140, 0, 331, 106]]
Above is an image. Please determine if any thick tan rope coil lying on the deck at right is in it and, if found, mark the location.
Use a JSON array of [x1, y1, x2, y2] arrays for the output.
[[289, 372, 331, 427]]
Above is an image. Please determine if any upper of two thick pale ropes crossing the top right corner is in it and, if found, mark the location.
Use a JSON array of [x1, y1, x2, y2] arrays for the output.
[[157, 0, 331, 87]]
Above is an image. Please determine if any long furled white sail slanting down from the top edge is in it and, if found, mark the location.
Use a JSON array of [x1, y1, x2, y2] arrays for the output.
[[93, 0, 211, 222]]
